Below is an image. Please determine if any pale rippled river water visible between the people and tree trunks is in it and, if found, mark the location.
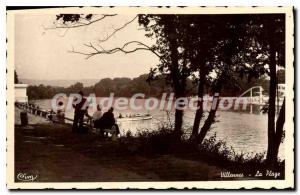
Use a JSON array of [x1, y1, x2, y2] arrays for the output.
[[31, 99, 284, 159]]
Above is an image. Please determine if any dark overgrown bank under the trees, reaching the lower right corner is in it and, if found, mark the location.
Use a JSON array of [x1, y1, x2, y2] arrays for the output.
[[119, 127, 285, 179]]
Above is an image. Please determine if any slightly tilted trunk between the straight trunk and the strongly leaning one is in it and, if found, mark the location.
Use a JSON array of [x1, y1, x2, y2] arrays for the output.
[[191, 71, 204, 138]]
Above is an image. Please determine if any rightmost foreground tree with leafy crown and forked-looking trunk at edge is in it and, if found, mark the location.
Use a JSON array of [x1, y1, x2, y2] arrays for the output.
[[231, 14, 285, 166]]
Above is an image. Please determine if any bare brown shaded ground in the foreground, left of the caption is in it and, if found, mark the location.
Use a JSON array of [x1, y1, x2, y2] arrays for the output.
[[15, 124, 223, 182]]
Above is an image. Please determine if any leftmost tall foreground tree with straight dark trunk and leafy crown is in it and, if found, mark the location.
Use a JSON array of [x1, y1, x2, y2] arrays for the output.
[[139, 15, 191, 139]]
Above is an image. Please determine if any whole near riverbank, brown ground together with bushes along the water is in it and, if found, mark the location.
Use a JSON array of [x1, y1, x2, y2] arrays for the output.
[[15, 124, 283, 182]]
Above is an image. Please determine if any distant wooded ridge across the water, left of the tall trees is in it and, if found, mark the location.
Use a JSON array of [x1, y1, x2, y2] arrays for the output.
[[27, 74, 190, 100]]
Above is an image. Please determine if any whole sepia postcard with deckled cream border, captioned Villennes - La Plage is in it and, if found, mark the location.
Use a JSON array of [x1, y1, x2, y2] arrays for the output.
[[7, 7, 295, 189]]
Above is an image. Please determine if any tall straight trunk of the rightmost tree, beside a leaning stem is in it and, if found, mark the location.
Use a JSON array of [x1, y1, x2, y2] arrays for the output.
[[267, 42, 277, 165]]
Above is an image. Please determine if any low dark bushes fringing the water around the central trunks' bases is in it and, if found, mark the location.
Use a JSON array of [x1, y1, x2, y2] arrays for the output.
[[118, 125, 272, 167]]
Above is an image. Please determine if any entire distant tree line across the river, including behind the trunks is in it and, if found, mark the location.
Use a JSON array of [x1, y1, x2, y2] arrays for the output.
[[27, 70, 284, 100]]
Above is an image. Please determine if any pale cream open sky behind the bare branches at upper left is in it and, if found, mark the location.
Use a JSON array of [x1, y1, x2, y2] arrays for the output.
[[15, 14, 159, 80]]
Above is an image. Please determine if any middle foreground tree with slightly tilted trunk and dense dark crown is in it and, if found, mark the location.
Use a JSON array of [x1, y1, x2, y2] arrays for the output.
[[182, 15, 231, 138]]
